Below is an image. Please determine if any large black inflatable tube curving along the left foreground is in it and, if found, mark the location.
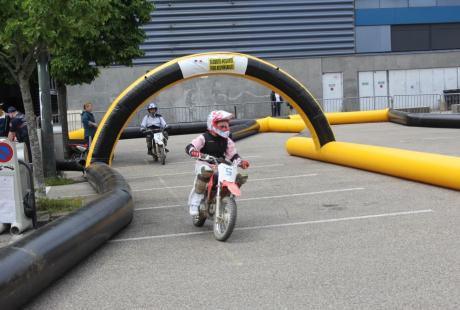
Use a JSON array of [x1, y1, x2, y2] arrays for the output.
[[0, 163, 133, 310]]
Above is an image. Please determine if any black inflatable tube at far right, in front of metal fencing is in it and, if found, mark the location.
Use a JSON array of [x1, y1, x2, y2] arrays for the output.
[[388, 109, 460, 128]]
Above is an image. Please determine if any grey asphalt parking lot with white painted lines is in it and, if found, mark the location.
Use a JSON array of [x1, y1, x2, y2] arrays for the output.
[[28, 123, 460, 309]]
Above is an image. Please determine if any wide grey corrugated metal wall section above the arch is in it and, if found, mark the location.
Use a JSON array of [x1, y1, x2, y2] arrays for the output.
[[134, 0, 355, 64]]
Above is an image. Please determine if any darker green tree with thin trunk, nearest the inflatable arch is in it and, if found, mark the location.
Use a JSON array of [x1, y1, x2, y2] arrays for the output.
[[51, 0, 153, 157]]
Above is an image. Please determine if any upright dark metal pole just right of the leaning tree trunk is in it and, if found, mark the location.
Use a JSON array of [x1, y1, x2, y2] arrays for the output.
[[38, 52, 56, 177]]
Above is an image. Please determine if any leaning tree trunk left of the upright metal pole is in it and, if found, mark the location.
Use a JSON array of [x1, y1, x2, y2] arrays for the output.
[[18, 74, 45, 195]]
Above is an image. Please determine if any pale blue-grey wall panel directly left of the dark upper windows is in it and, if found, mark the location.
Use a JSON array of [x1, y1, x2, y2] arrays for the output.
[[356, 25, 391, 53]]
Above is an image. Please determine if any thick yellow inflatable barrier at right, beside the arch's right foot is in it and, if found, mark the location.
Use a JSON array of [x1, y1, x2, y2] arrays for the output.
[[286, 137, 460, 190]]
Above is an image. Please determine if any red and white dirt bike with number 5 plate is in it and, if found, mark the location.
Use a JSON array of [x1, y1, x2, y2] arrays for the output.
[[193, 155, 246, 241]]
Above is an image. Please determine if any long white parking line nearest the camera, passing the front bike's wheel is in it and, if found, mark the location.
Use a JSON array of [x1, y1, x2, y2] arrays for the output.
[[110, 209, 434, 242]]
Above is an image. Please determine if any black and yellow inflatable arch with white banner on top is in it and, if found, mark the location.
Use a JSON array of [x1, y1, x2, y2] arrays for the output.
[[86, 52, 335, 167]]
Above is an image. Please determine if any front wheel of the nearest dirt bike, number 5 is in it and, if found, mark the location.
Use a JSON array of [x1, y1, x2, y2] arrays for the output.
[[214, 197, 236, 241]]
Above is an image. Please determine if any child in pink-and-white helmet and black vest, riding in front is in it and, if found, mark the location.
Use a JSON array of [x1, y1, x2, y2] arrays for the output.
[[185, 111, 249, 216]]
